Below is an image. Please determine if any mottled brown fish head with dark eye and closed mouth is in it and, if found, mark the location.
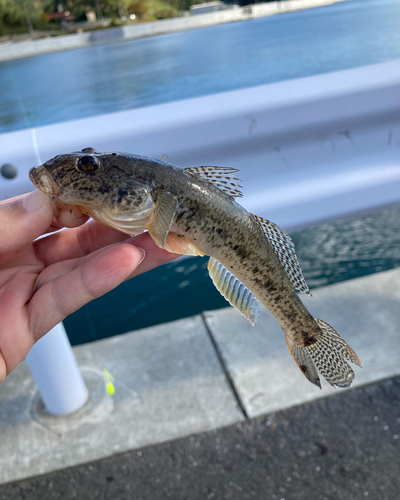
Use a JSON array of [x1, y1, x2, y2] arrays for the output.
[[29, 148, 154, 234]]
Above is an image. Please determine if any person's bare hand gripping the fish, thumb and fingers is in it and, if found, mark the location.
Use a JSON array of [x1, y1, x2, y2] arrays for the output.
[[0, 191, 177, 382]]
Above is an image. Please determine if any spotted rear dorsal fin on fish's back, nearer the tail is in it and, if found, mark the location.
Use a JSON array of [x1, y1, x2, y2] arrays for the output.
[[252, 214, 310, 294]]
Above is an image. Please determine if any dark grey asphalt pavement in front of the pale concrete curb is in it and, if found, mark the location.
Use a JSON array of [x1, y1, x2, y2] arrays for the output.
[[0, 377, 400, 500]]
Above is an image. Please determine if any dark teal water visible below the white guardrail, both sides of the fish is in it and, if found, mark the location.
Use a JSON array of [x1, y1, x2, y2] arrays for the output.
[[64, 207, 400, 344]]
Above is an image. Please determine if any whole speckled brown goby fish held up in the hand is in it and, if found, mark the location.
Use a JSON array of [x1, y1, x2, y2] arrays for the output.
[[29, 148, 361, 387]]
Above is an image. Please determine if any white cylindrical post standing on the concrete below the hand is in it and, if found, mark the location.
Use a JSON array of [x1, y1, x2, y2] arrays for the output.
[[26, 323, 88, 415]]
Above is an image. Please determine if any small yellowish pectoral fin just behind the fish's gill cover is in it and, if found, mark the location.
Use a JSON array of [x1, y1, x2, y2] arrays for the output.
[[147, 191, 178, 248]]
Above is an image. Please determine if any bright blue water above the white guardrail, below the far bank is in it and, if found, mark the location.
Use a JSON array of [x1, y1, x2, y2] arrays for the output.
[[0, 0, 400, 133]]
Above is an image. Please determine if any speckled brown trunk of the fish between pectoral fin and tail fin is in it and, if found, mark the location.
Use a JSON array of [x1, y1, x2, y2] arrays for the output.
[[167, 174, 318, 341]]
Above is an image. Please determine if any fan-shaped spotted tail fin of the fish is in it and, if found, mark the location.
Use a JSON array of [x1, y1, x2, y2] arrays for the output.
[[286, 319, 361, 388]]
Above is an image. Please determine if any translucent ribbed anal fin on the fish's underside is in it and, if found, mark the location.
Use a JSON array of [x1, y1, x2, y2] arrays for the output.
[[208, 257, 259, 326]]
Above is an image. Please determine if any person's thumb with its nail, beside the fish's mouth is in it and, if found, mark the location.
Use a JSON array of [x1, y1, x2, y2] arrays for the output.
[[0, 190, 53, 257]]
